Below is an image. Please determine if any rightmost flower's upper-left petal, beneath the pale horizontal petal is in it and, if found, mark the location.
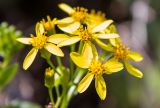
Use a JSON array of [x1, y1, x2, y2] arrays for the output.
[[95, 39, 114, 52]]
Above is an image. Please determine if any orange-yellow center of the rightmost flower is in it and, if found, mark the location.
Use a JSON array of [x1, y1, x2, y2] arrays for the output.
[[114, 44, 129, 60]]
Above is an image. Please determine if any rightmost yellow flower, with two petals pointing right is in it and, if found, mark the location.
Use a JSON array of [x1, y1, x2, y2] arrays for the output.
[[99, 39, 143, 78]]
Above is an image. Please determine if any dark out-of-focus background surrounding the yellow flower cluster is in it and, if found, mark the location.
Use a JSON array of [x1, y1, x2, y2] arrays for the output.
[[0, 0, 160, 108]]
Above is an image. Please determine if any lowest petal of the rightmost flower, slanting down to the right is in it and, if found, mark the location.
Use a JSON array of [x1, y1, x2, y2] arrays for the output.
[[124, 61, 143, 78]]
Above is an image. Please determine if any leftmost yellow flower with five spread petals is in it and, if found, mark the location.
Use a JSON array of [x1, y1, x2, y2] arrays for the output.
[[17, 23, 66, 70]]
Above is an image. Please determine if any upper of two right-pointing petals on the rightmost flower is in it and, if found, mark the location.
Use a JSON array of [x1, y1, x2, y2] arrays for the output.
[[128, 52, 143, 62]]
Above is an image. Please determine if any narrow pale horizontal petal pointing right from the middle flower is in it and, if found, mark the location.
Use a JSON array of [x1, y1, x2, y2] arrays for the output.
[[95, 33, 120, 39]]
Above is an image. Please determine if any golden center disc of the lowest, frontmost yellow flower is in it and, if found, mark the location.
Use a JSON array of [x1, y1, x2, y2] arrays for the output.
[[89, 60, 104, 75]]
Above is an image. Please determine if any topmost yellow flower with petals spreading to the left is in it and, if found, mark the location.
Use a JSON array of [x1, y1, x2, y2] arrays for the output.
[[57, 3, 88, 33]]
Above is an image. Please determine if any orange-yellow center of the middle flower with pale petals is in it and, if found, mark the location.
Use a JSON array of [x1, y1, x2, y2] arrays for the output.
[[79, 28, 92, 41]]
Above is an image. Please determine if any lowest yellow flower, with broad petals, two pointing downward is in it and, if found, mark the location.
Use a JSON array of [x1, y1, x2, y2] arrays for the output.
[[70, 44, 123, 100]]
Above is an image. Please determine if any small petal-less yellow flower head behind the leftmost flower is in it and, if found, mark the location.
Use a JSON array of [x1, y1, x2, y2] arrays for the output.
[[41, 16, 57, 31]]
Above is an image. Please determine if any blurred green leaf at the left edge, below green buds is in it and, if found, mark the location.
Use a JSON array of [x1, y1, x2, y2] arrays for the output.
[[0, 63, 18, 89]]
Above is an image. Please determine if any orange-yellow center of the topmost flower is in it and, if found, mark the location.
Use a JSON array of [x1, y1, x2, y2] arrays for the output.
[[71, 7, 88, 22]]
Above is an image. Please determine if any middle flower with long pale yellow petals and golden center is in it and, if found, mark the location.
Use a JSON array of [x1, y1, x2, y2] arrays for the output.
[[57, 20, 119, 56]]
